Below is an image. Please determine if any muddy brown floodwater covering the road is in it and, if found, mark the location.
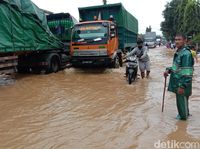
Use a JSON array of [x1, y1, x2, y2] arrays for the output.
[[0, 47, 200, 149]]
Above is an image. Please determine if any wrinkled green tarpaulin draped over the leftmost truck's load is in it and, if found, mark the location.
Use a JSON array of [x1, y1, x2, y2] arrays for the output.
[[0, 0, 62, 52]]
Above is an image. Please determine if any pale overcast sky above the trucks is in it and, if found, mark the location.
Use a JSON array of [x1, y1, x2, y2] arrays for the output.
[[32, 0, 170, 34]]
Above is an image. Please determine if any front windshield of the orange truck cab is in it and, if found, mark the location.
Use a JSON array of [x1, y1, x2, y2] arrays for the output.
[[72, 23, 108, 41]]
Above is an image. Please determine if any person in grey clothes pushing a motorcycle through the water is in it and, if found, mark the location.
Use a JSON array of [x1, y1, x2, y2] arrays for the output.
[[126, 38, 150, 79]]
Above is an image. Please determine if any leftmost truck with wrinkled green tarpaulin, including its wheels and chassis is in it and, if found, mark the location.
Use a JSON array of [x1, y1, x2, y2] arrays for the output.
[[0, 0, 68, 73]]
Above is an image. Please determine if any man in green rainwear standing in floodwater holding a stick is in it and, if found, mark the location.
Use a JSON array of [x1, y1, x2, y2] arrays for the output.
[[164, 34, 194, 120]]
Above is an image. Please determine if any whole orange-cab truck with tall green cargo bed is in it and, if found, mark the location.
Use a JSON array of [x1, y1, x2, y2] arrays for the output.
[[70, 3, 138, 68]]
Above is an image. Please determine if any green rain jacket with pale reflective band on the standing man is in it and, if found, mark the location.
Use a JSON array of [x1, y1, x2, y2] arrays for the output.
[[167, 47, 194, 96]]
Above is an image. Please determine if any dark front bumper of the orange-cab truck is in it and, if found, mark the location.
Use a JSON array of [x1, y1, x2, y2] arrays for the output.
[[71, 56, 112, 67]]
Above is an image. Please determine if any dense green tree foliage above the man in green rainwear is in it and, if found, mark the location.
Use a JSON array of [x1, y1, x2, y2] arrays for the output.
[[161, 0, 200, 40]]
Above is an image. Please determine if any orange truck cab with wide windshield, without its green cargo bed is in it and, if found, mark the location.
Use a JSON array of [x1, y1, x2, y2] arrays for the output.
[[70, 20, 121, 67]]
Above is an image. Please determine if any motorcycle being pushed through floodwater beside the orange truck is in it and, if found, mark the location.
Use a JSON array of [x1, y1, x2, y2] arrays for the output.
[[125, 56, 138, 84]]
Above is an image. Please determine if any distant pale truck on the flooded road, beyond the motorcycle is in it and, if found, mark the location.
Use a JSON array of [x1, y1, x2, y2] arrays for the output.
[[144, 32, 156, 48]]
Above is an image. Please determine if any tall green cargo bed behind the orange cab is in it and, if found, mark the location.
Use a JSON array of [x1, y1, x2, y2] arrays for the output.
[[79, 3, 138, 49]]
